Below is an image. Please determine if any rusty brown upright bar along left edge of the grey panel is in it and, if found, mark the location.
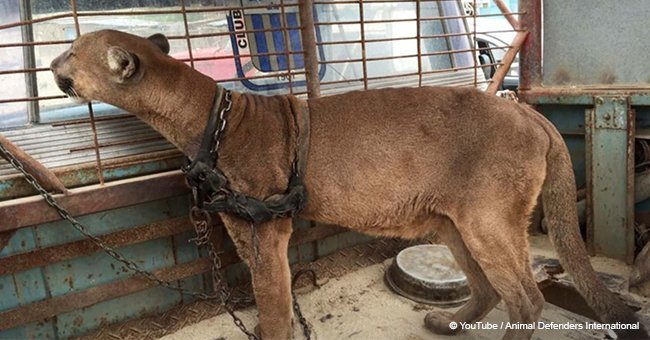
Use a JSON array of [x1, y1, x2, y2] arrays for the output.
[[519, 0, 542, 90]]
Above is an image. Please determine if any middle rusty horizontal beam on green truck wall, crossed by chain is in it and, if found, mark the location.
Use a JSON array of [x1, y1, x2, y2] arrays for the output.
[[0, 217, 192, 276]]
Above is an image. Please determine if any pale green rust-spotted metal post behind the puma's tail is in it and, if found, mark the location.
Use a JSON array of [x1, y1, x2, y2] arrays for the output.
[[585, 96, 635, 263]]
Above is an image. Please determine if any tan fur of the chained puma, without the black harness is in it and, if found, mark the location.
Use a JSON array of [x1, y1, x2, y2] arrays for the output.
[[52, 31, 646, 339]]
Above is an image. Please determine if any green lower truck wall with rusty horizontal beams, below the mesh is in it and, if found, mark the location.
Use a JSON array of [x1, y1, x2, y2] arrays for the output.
[[0, 167, 370, 339]]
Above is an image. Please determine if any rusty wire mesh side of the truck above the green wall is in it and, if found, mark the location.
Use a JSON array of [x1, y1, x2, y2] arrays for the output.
[[0, 0, 517, 197]]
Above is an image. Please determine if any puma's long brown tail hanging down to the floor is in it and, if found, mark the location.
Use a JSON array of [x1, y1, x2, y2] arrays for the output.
[[542, 122, 649, 339]]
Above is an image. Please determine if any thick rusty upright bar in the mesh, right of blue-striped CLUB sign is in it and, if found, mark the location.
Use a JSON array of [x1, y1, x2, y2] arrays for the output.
[[299, 0, 320, 98]]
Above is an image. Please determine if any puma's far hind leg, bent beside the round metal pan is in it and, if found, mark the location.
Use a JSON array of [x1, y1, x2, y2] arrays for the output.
[[424, 217, 499, 335]]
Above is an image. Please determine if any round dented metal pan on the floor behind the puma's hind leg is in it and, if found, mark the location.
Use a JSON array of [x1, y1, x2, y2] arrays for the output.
[[385, 244, 470, 306]]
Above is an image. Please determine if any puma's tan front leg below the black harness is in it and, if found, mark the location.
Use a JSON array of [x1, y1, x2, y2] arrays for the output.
[[224, 216, 293, 340]]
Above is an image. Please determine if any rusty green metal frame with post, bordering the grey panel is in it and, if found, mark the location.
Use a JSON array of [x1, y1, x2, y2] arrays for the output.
[[519, 0, 650, 263]]
